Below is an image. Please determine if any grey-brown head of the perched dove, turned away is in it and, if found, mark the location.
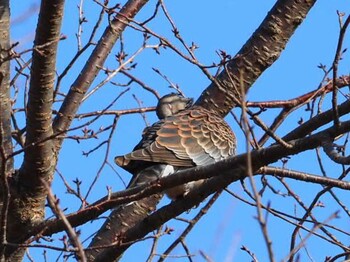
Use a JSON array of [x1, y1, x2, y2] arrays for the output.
[[156, 93, 193, 119]]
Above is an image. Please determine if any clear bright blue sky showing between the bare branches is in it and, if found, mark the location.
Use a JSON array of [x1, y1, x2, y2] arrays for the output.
[[12, 0, 350, 261]]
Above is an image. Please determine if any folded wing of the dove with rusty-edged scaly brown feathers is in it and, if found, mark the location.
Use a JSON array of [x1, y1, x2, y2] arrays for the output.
[[116, 107, 236, 167]]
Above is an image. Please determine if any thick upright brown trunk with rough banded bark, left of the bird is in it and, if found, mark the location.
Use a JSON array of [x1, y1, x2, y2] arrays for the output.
[[8, 0, 64, 259]]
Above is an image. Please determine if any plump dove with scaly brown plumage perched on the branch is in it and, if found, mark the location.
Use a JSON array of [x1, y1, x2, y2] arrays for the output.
[[115, 93, 236, 200]]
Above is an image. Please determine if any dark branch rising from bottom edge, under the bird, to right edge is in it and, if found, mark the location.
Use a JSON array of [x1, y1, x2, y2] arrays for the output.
[[89, 121, 350, 261]]
